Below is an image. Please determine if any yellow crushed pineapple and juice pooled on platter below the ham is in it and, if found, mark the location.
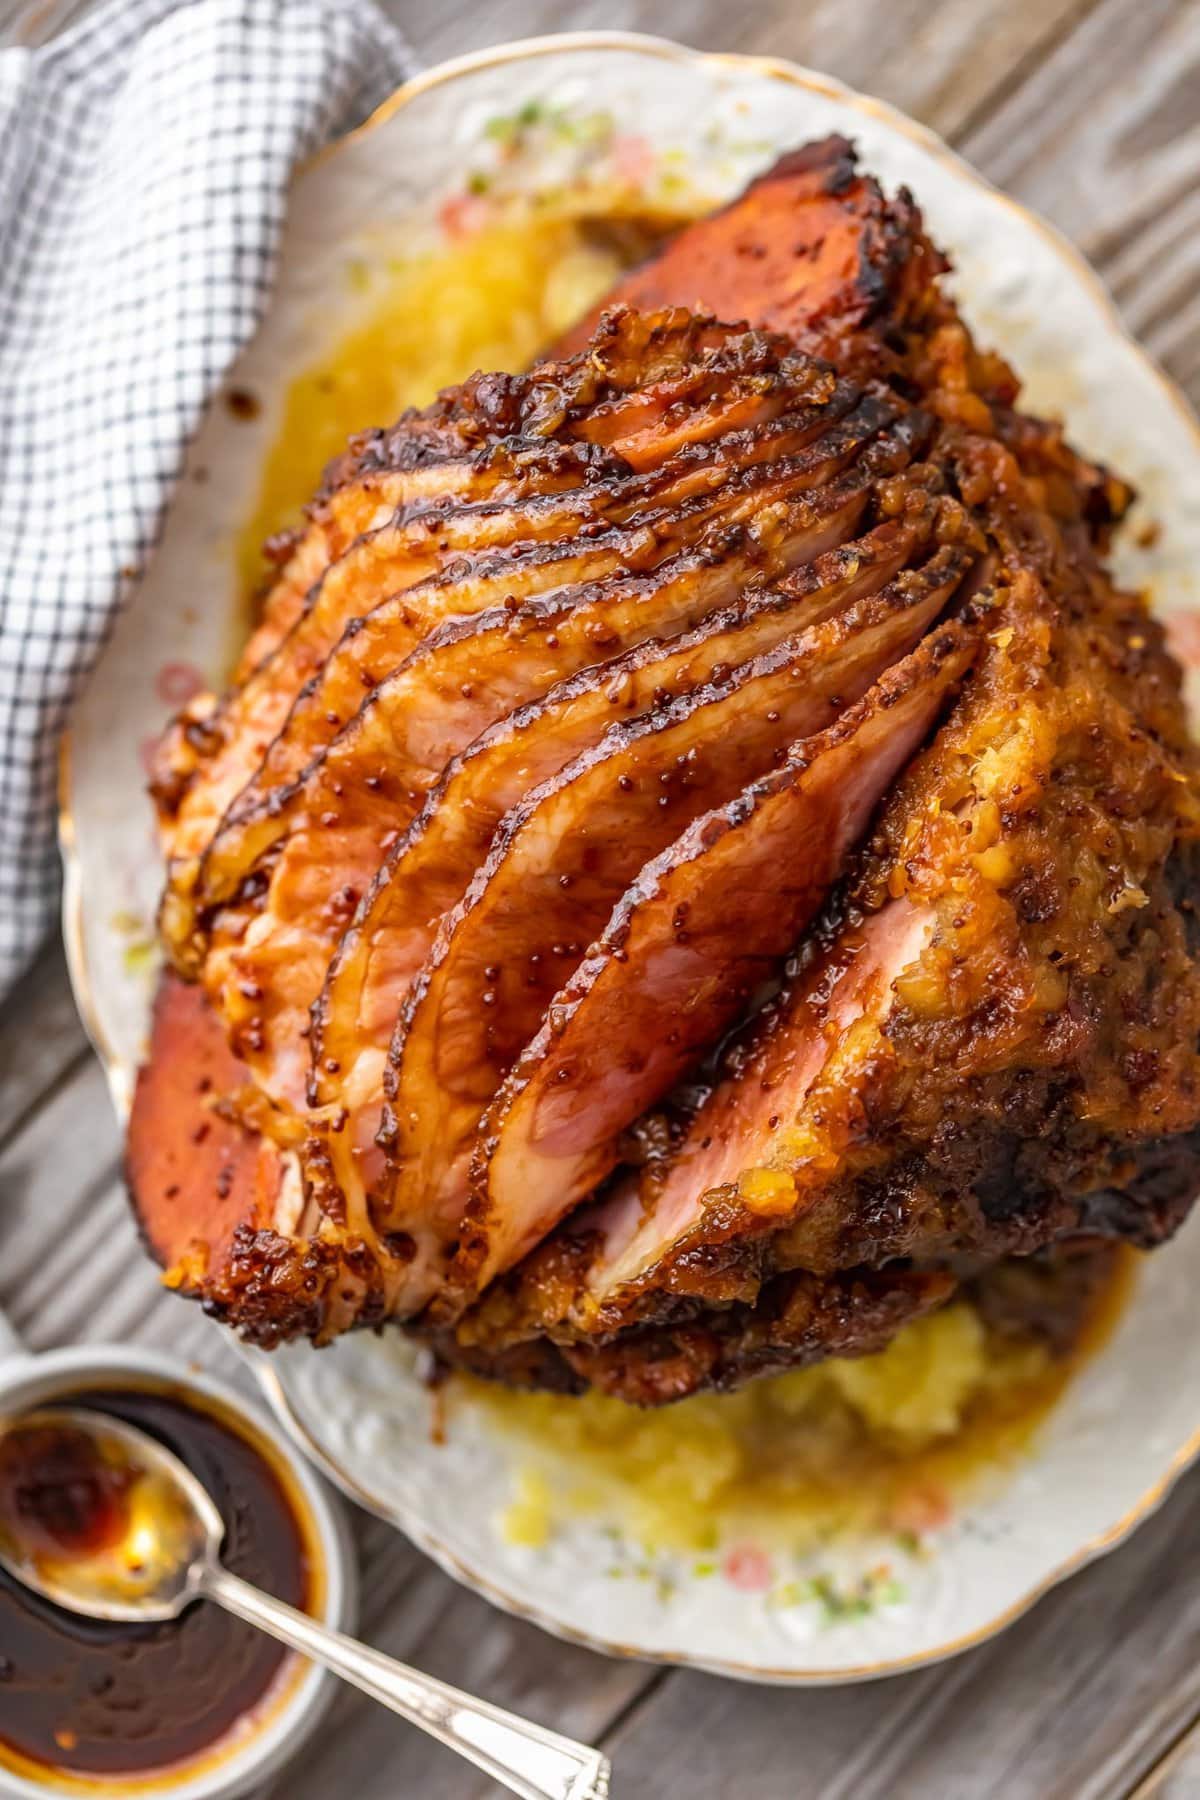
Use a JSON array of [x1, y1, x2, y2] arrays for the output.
[[450, 1264, 1132, 1552]]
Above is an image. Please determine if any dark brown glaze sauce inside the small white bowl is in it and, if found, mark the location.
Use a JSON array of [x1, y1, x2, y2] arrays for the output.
[[0, 1388, 313, 1791]]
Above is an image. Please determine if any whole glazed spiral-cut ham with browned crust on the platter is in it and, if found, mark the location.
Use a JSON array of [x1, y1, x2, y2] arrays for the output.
[[128, 139, 1200, 1406]]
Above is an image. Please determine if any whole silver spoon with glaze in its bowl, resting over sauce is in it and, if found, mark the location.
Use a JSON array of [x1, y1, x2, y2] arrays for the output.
[[0, 1408, 610, 1800]]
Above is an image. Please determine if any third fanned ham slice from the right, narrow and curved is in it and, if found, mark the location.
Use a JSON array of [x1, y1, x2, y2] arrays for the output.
[[305, 509, 970, 1238]]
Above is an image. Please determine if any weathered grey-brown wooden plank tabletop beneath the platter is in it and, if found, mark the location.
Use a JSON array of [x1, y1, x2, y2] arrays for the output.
[[0, 0, 1200, 1800]]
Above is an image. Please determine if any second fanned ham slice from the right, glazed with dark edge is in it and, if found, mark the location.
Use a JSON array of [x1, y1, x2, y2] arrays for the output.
[[376, 561, 978, 1303]]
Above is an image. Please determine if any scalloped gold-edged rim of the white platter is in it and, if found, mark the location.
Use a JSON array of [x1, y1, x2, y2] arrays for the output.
[[59, 31, 1200, 1687]]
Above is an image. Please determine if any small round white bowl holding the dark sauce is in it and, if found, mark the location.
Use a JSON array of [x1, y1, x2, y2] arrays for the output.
[[0, 1314, 358, 1800]]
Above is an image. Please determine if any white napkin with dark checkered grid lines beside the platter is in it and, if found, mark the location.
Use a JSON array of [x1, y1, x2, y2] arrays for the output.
[[0, 0, 410, 992]]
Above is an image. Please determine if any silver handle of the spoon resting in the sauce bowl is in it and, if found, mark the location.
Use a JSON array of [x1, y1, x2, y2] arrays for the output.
[[200, 1564, 610, 1800]]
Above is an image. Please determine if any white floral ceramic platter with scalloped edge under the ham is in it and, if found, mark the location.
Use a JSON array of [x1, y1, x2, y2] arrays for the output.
[[63, 34, 1200, 1683]]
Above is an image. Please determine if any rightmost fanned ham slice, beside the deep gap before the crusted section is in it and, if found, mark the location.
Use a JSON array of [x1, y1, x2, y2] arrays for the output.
[[453, 615, 973, 1292]]
